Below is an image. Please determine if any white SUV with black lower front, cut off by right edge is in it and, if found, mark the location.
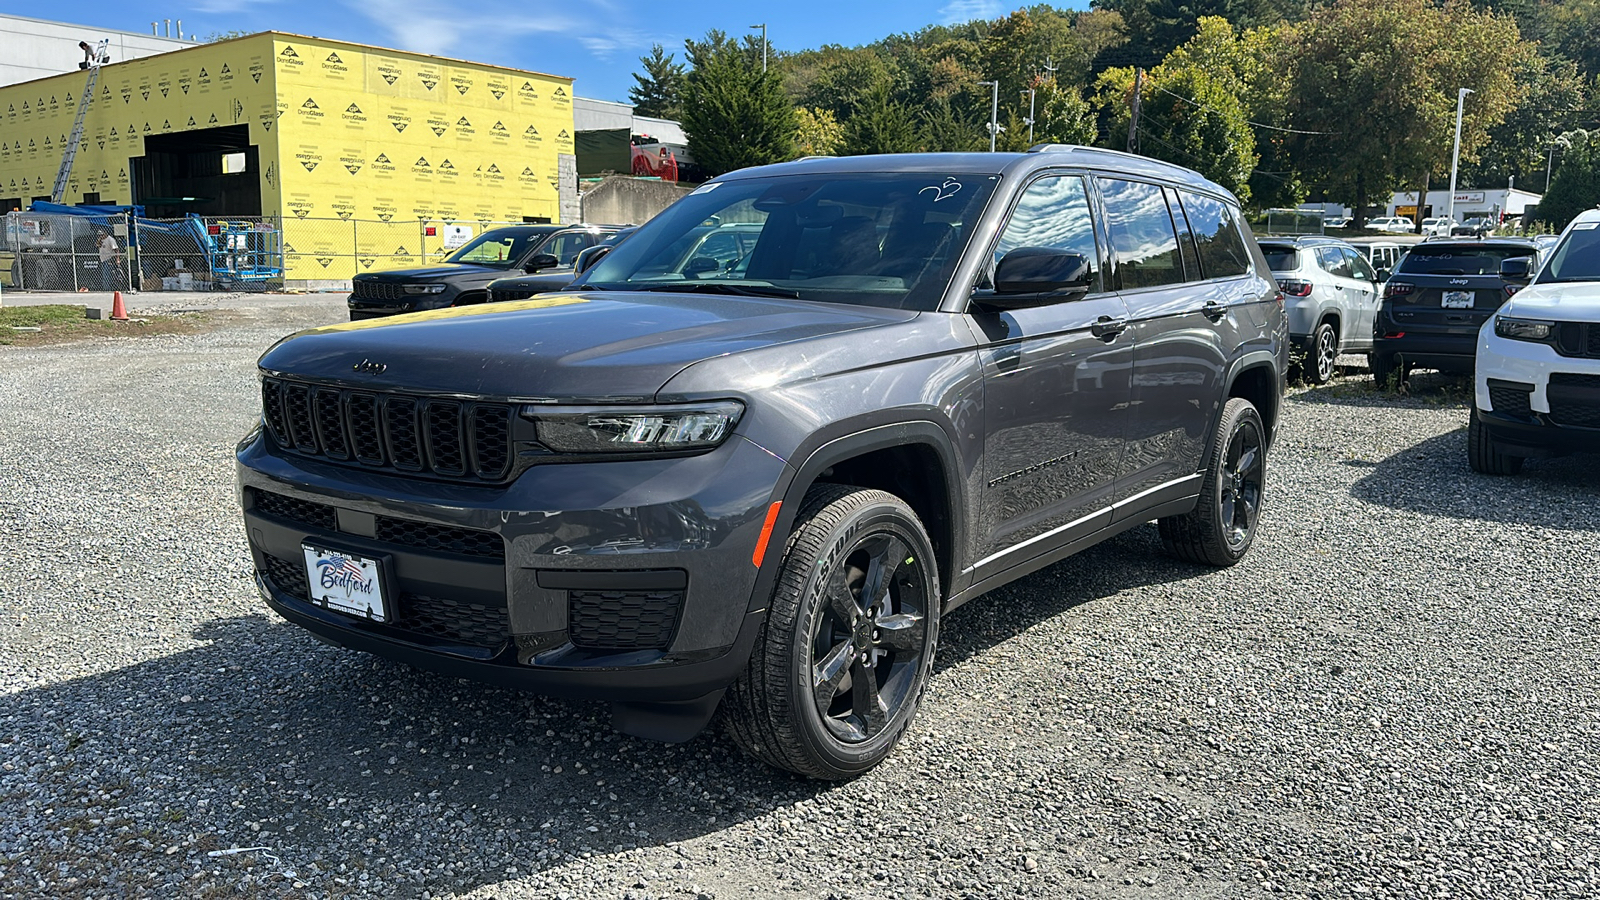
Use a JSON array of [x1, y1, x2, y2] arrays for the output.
[[1467, 210, 1600, 476]]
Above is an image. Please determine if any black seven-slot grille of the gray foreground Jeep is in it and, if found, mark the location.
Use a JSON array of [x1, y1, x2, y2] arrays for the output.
[[261, 378, 512, 480]]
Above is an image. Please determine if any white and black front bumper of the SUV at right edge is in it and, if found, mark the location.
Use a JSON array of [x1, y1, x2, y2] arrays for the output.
[[1472, 331, 1600, 456]]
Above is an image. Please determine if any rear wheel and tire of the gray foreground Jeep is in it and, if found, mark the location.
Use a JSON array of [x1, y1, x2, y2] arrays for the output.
[[1157, 397, 1267, 567]]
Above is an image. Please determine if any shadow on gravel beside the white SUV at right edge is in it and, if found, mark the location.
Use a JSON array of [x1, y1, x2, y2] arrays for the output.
[[1350, 426, 1600, 532]]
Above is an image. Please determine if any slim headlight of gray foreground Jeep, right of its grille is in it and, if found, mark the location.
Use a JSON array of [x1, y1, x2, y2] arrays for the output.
[[522, 400, 744, 453]]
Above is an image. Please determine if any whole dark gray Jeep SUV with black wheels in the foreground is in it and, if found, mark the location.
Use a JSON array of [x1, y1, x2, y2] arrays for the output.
[[238, 146, 1288, 778]]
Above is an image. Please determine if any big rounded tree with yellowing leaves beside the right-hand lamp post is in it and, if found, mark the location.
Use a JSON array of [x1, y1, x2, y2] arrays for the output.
[[1282, 0, 1533, 224]]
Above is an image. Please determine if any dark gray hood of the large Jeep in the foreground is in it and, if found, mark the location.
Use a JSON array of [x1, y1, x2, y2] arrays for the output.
[[259, 291, 917, 402]]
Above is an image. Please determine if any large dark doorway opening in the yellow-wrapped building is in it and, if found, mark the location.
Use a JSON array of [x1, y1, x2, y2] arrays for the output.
[[130, 125, 261, 219]]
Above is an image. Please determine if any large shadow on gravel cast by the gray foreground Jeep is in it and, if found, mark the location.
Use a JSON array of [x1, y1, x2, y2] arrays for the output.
[[0, 527, 1200, 897]]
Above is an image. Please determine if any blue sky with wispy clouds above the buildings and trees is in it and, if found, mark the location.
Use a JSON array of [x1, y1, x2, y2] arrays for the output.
[[62, 0, 1024, 99]]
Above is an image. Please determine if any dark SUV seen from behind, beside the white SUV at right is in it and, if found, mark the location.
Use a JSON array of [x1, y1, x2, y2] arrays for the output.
[[1368, 237, 1539, 386]]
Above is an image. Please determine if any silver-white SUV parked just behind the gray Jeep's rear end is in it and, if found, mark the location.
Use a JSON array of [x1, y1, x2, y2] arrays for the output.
[[1261, 237, 1381, 384]]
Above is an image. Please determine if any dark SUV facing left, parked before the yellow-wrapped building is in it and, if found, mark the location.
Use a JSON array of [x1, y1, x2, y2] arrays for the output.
[[346, 224, 619, 320]]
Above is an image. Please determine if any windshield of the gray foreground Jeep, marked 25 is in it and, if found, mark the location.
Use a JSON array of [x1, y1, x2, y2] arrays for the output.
[[582, 173, 998, 309]]
